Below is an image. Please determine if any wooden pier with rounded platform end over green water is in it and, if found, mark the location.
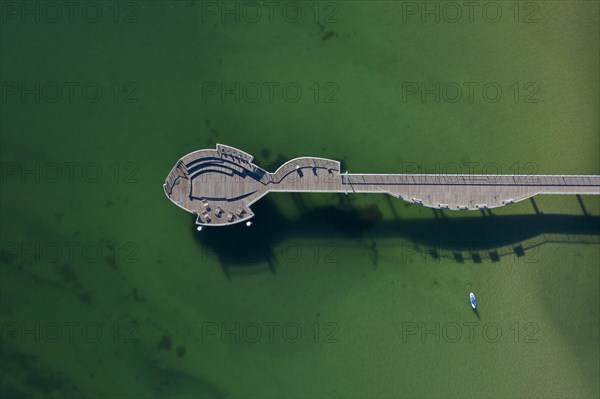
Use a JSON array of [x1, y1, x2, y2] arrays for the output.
[[164, 144, 600, 226]]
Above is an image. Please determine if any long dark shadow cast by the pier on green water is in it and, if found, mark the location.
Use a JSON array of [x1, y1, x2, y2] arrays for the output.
[[190, 194, 600, 276]]
